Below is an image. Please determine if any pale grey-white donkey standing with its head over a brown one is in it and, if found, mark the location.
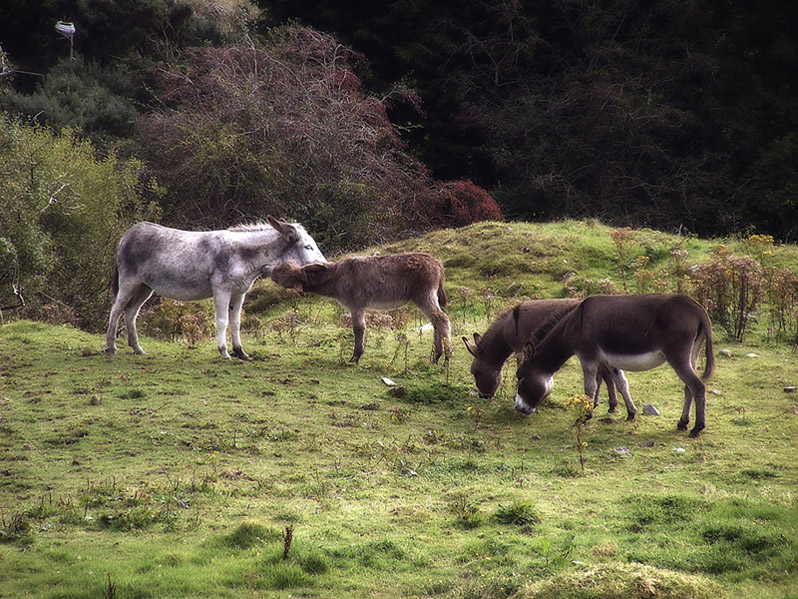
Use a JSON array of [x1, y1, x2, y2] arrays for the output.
[[105, 216, 325, 360]]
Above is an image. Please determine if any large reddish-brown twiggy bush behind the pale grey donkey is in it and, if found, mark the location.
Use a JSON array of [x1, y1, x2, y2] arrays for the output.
[[135, 26, 501, 248]]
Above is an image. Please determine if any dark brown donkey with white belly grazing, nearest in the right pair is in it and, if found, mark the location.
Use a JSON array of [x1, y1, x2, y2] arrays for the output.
[[515, 294, 715, 437]]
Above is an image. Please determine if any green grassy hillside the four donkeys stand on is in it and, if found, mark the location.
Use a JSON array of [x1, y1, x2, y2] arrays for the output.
[[0, 222, 798, 599]]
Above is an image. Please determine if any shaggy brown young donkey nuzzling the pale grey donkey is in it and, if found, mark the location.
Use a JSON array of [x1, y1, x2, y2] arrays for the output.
[[272, 253, 451, 362]]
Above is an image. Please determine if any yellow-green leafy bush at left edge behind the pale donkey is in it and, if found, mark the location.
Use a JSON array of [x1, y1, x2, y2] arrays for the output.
[[0, 115, 146, 328]]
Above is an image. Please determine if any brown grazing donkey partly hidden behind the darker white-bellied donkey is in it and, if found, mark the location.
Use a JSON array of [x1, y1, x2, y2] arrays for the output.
[[463, 299, 618, 412]]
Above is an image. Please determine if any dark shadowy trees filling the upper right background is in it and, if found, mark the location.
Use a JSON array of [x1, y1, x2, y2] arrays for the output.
[[262, 0, 798, 240]]
